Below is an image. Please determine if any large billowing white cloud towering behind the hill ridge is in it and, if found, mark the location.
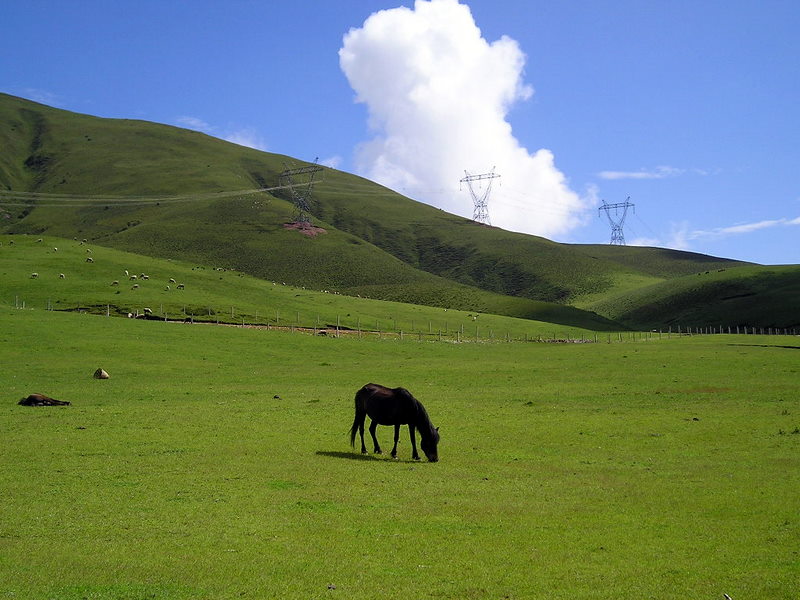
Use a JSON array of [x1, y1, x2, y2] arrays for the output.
[[339, 0, 589, 236]]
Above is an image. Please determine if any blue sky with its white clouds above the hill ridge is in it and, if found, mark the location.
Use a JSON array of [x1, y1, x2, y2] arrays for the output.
[[0, 0, 800, 264]]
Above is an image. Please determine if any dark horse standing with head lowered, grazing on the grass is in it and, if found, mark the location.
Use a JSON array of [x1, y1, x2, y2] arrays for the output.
[[350, 383, 439, 462]]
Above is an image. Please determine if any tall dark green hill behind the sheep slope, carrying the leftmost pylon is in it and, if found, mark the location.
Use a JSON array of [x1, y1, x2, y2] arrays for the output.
[[0, 94, 792, 328]]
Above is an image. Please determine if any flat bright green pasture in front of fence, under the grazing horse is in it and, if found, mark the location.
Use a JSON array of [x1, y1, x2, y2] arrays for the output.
[[0, 306, 800, 600]]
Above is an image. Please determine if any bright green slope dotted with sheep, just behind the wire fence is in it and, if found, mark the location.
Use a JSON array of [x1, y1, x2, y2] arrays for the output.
[[0, 235, 620, 339]]
